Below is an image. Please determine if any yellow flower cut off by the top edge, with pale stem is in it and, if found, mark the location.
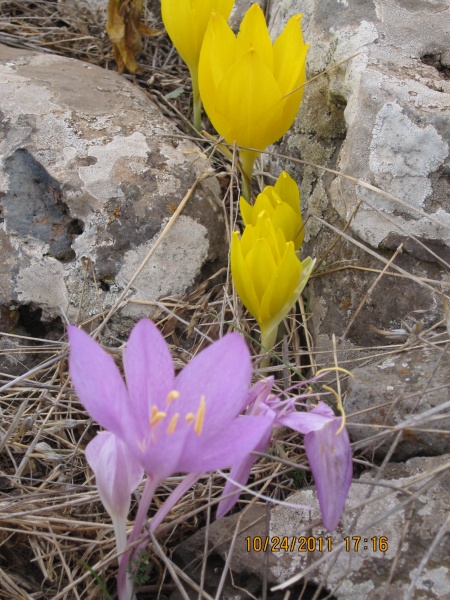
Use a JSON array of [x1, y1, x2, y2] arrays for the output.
[[161, 0, 234, 129]]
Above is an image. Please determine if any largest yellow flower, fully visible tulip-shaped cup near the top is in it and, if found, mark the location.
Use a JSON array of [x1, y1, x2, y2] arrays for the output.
[[199, 3, 308, 199]]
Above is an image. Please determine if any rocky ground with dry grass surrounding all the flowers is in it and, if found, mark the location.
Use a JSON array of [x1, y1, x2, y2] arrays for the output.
[[0, 0, 450, 600]]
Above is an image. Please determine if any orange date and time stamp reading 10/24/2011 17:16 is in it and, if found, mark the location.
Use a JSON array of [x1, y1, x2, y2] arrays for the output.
[[245, 535, 389, 553]]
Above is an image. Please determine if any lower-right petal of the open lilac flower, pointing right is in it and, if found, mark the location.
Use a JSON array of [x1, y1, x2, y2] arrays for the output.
[[179, 416, 273, 473]]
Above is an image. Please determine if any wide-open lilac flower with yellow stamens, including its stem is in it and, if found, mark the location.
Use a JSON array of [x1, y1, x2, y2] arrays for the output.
[[68, 319, 271, 599]]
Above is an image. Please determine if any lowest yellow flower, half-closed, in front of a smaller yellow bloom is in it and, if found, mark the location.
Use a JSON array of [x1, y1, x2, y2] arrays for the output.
[[231, 214, 315, 349]]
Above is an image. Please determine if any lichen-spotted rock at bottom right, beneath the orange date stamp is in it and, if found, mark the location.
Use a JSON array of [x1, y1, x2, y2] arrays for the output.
[[171, 454, 450, 600]]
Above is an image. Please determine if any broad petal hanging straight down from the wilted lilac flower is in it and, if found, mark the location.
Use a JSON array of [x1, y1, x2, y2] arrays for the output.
[[305, 417, 352, 531]]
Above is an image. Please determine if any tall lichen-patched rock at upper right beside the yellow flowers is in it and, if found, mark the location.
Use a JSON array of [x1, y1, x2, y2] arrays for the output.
[[272, 0, 450, 349]]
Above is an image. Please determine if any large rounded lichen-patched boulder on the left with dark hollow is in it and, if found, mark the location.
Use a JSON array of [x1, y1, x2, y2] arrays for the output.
[[0, 47, 227, 338]]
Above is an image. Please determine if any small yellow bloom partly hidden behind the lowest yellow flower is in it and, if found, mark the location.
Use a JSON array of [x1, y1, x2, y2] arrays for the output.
[[240, 171, 305, 250]]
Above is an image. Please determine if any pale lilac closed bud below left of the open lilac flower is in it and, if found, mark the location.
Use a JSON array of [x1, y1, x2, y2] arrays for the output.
[[86, 431, 144, 519]]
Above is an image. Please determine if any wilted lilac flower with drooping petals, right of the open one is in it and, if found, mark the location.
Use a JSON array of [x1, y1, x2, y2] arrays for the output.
[[217, 378, 352, 531]]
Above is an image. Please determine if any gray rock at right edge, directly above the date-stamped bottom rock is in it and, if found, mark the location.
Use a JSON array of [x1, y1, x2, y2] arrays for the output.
[[345, 346, 450, 460]]
